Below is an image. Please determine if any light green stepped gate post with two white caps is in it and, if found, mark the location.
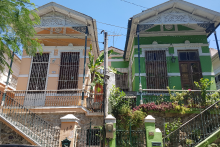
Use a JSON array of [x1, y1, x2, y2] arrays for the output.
[[144, 115, 163, 147]]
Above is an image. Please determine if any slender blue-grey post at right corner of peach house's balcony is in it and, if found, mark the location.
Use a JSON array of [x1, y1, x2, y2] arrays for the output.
[[81, 26, 88, 106]]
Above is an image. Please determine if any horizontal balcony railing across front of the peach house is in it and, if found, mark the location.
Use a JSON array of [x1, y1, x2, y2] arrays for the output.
[[6, 89, 103, 112]]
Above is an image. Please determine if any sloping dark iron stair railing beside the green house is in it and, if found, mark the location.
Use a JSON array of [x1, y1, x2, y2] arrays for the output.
[[163, 101, 220, 147]]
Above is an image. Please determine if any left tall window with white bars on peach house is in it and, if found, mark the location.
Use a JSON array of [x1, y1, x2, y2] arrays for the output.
[[28, 53, 49, 90]]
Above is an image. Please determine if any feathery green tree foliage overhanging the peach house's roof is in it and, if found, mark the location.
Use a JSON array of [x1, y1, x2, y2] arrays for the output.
[[0, 0, 42, 71]]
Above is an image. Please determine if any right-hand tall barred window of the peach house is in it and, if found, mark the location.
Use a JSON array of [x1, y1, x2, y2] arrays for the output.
[[58, 52, 80, 90]]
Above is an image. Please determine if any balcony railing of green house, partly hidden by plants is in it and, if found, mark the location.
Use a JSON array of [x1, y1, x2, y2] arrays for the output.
[[142, 89, 220, 108]]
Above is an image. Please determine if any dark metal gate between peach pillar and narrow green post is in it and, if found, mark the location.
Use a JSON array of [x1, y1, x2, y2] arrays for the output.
[[74, 122, 104, 147]]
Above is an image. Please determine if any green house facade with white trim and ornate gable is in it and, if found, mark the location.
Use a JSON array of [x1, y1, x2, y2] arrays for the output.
[[111, 0, 220, 95]]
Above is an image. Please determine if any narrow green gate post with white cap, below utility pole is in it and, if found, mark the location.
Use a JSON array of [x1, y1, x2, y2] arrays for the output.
[[105, 114, 116, 147]]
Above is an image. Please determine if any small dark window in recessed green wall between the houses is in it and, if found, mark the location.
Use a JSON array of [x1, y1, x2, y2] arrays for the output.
[[115, 73, 128, 91]]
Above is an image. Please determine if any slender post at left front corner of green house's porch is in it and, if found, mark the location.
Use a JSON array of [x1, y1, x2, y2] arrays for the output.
[[137, 25, 143, 104]]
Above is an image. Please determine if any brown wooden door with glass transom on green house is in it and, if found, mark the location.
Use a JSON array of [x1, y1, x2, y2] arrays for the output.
[[178, 51, 202, 89]]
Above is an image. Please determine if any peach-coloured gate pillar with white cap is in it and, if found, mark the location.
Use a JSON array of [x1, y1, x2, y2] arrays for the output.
[[59, 114, 79, 147]]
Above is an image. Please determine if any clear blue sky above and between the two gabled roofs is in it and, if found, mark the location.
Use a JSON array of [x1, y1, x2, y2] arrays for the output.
[[31, 0, 220, 50]]
